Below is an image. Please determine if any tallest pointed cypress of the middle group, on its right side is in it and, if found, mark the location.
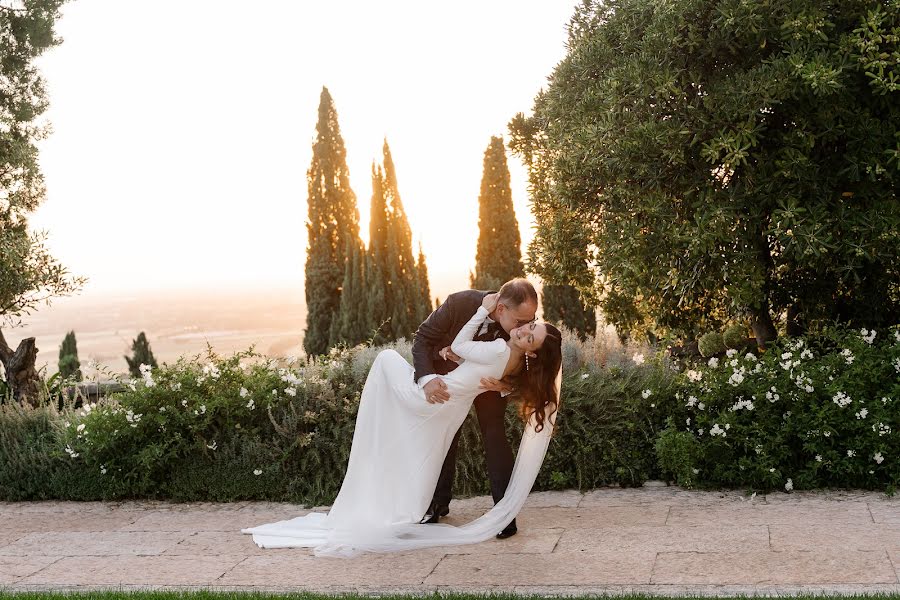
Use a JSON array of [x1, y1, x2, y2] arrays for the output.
[[384, 140, 421, 339]]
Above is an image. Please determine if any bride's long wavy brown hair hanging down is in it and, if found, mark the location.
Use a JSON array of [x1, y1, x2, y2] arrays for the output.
[[514, 323, 562, 431]]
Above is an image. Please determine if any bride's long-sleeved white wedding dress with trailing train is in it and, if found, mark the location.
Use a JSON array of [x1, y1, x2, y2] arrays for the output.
[[241, 307, 562, 556]]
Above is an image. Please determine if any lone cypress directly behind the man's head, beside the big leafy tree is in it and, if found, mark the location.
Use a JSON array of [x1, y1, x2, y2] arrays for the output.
[[471, 136, 525, 290]]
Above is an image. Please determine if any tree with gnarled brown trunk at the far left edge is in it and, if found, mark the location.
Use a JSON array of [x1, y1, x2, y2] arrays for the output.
[[0, 0, 85, 401]]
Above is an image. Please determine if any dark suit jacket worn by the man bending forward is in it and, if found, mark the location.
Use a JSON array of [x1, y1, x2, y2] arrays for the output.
[[413, 290, 509, 381]]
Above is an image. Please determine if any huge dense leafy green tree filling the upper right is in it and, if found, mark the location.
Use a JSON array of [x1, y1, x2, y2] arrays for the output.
[[510, 0, 900, 344]]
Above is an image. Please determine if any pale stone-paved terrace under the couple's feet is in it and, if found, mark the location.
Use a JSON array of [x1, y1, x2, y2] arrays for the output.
[[0, 485, 900, 595]]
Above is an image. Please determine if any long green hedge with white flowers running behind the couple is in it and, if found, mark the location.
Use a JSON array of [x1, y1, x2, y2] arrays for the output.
[[0, 329, 900, 505]]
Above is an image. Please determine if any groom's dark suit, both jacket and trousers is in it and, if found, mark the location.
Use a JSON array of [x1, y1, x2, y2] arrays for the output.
[[412, 290, 514, 506]]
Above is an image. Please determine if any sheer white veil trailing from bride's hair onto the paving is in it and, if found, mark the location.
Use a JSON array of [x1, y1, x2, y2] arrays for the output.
[[314, 365, 562, 556]]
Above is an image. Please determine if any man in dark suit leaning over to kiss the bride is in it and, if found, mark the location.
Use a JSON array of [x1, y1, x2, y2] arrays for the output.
[[412, 279, 538, 539]]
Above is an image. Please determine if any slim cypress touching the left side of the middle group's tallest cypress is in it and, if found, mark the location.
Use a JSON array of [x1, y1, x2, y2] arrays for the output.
[[366, 163, 392, 344]]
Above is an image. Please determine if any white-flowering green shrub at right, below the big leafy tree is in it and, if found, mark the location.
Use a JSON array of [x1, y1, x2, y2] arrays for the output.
[[658, 328, 900, 491]]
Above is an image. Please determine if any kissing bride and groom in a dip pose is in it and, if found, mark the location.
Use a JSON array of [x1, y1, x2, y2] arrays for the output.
[[241, 279, 562, 556]]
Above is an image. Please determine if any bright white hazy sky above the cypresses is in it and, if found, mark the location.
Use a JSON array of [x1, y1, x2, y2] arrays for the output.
[[31, 0, 574, 298]]
